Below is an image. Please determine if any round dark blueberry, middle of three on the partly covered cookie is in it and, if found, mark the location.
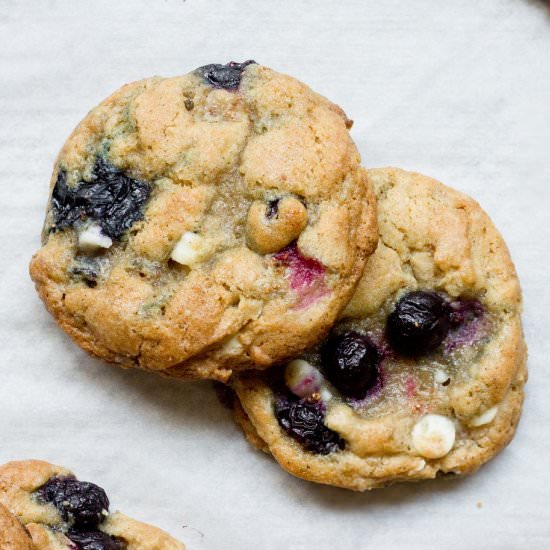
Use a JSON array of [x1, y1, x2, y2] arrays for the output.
[[321, 331, 379, 398]]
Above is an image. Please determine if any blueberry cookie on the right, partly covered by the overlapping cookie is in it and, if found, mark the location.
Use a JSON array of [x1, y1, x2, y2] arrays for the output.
[[233, 169, 527, 491]]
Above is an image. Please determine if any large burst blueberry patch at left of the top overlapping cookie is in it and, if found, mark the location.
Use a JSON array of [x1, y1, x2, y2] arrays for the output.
[[52, 157, 150, 239]]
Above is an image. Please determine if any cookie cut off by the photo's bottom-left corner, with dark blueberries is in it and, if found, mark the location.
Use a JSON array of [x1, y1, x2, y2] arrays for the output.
[[0, 460, 185, 550]]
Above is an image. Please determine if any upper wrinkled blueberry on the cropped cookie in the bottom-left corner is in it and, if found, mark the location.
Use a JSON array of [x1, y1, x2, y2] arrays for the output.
[[37, 477, 109, 530]]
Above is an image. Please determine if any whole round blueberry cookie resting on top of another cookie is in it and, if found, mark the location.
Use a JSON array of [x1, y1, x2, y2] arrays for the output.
[[30, 62, 377, 380]]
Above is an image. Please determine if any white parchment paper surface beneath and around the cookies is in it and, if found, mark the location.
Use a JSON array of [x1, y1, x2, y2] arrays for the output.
[[0, 0, 550, 550]]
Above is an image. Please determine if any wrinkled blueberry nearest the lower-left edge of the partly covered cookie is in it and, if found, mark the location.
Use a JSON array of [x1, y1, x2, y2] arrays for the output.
[[275, 396, 345, 455]]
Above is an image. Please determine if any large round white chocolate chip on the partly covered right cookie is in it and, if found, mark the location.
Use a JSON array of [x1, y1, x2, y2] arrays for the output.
[[412, 414, 456, 458]]
